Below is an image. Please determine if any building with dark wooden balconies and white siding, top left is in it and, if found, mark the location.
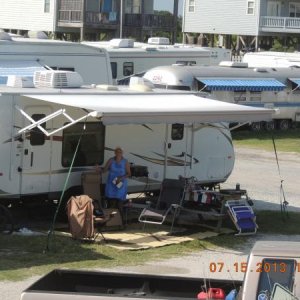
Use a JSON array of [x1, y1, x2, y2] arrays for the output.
[[0, 0, 178, 40]]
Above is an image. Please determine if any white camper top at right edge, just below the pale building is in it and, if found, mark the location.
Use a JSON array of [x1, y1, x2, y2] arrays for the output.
[[242, 51, 300, 68]]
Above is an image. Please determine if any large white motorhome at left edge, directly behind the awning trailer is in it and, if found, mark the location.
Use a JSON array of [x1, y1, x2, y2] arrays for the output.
[[0, 32, 112, 84]]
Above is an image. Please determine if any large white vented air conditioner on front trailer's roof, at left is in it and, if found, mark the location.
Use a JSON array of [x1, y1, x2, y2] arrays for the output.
[[33, 70, 83, 88]]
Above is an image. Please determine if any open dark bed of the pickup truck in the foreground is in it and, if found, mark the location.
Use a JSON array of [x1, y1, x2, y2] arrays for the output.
[[21, 269, 242, 300]]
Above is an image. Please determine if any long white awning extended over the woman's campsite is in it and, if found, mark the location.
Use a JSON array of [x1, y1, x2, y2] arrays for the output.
[[23, 92, 274, 125]]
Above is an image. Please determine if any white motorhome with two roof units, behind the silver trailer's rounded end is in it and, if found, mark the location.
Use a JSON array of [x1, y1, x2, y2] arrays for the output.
[[83, 37, 231, 80]]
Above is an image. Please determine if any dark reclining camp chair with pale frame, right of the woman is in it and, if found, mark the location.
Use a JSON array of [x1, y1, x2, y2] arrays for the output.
[[139, 179, 185, 232]]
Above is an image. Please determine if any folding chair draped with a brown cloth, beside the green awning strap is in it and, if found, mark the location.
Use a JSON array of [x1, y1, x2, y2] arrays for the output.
[[67, 195, 117, 241]]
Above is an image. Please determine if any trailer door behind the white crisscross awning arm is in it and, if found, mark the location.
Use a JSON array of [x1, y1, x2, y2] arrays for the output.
[[21, 106, 52, 196]]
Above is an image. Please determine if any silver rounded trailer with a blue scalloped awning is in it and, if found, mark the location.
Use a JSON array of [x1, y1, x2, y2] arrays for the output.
[[144, 62, 300, 130]]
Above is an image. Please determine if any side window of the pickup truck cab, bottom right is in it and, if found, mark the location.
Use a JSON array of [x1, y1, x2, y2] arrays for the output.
[[255, 259, 296, 299]]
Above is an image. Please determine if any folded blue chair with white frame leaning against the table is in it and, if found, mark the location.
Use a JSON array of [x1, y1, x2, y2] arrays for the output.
[[225, 199, 258, 235]]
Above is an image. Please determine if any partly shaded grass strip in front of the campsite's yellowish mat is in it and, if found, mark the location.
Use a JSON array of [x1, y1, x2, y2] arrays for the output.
[[0, 211, 300, 281]]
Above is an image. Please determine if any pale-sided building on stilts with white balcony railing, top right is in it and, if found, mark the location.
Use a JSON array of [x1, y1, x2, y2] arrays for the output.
[[182, 0, 300, 49]]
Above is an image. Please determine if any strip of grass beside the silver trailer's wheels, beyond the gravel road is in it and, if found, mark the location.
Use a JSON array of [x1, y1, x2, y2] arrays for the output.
[[232, 128, 300, 153]]
